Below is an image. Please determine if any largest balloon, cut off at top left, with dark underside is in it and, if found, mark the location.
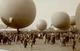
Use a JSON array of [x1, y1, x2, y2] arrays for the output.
[[0, 0, 36, 28]]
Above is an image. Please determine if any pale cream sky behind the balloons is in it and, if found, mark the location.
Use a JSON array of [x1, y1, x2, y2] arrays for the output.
[[0, 0, 80, 29]]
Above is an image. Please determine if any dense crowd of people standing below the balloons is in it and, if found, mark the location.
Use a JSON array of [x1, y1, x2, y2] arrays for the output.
[[0, 32, 80, 51]]
